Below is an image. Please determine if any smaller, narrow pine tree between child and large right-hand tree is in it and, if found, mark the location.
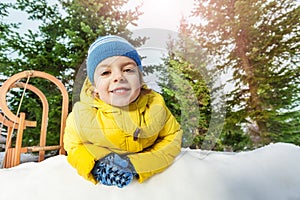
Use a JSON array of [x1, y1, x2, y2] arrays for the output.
[[160, 18, 214, 148]]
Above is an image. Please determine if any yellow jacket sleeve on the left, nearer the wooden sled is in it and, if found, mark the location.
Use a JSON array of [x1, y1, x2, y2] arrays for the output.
[[64, 112, 110, 184]]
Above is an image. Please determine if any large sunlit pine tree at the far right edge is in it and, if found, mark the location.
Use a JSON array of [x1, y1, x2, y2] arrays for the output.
[[190, 0, 300, 145]]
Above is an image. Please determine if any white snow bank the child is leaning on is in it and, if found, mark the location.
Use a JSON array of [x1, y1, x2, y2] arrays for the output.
[[0, 143, 300, 200]]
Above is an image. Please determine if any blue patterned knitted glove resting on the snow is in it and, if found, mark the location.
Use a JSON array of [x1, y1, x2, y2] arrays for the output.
[[92, 153, 137, 188]]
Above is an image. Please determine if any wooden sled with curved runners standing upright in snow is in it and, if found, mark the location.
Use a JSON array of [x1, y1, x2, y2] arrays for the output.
[[0, 71, 69, 168]]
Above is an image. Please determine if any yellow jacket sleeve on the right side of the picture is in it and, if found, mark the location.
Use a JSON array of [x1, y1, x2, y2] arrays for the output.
[[128, 107, 182, 182]]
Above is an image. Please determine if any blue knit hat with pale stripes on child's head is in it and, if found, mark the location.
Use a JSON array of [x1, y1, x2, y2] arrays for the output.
[[87, 35, 143, 83]]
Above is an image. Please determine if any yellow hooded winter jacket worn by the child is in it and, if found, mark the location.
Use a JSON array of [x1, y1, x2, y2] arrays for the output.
[[64, 80, 182, 183]]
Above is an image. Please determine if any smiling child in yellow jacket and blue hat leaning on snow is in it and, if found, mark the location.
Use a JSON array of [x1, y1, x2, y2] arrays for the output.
[[64, 35, 182, 187]]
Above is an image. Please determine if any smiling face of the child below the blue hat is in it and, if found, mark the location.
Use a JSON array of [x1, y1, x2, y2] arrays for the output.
[[94, 56, 141, 107]]
